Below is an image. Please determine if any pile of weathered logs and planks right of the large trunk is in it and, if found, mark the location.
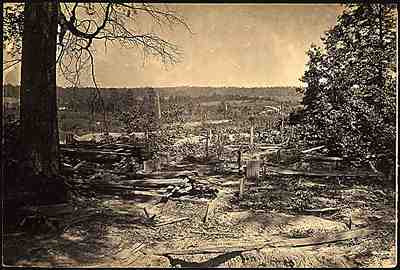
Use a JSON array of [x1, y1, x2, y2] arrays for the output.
[[61, 142, 217, 198]]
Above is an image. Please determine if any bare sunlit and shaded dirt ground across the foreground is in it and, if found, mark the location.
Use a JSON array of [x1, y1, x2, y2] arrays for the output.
[[3, 160, 396, 267]]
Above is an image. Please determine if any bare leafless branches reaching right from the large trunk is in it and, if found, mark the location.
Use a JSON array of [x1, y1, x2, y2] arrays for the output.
[[52, 2, 192, 131]]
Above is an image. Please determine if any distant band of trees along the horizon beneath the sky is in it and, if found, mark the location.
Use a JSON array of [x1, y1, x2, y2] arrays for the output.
[[3, 85, 299, 112]]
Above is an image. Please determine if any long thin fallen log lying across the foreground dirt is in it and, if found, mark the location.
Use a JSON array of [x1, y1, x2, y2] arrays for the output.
[[155, 229, 371, 256]]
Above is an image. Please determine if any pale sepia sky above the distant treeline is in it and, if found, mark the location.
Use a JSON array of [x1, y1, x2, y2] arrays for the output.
[[4, 4, 342, 87]]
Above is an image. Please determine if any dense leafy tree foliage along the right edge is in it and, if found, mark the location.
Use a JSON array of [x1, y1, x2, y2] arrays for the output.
[[294, 4, 397, 177]]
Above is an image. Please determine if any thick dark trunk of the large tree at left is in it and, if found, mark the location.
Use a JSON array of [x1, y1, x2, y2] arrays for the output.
[[20, 1, 60, 178]]
